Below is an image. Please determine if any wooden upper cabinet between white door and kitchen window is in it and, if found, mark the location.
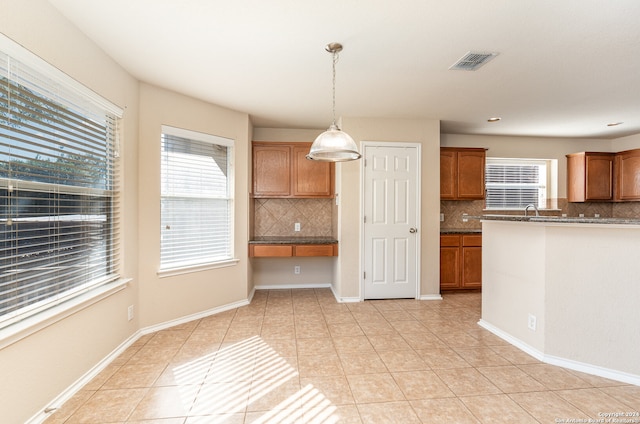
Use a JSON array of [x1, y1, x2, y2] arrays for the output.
[[440, 147, 486, 200]]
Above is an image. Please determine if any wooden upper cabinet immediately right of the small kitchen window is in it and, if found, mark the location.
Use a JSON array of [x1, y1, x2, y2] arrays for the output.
[[567, 152, 615, 202]]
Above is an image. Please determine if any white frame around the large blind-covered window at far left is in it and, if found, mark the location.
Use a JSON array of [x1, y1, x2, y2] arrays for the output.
[[0, 34, 124, 334]]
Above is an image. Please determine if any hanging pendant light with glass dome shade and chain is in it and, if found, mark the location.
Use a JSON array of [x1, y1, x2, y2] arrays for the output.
[[307, 43, 361, 162]]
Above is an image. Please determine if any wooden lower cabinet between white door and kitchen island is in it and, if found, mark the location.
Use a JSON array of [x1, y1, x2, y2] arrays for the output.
[[440, 233, 482, 290]]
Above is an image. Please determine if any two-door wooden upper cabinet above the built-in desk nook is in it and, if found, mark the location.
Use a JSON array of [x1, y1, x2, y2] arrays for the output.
[[253, 142, 335, 198]]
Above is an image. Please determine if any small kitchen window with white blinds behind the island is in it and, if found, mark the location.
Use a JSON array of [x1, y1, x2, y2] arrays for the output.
[[485, 158, 555, 210]]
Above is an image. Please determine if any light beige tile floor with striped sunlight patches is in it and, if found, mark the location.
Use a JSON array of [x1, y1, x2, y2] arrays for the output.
[[46, 289, 640, 424]]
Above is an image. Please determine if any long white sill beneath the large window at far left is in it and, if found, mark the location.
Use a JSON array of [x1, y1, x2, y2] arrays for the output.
[[0, 278, 131, 349]]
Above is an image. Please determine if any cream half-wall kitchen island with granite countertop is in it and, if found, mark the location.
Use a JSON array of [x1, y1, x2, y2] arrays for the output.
[[476, 215, 640, 385]]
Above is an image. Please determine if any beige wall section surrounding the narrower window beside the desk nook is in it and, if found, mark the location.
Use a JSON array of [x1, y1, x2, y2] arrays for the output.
[[138, 84, 250, 327]]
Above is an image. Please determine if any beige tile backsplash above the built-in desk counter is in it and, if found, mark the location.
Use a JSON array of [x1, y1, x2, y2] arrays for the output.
[[253, 199, 334, 237]]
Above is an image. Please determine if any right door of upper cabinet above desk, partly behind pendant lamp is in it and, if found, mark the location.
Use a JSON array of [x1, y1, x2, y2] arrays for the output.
[[292, 143, 335, 197]]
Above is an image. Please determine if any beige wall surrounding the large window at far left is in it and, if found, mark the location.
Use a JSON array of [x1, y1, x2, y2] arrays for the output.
[[0, 0, 138, 423]]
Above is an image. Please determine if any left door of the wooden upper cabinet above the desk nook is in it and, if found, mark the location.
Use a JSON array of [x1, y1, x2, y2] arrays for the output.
[[253, 144, 291, 197]]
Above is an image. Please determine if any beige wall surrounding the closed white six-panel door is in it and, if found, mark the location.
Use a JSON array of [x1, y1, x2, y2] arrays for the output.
[[334, 118, 440, 299]]
